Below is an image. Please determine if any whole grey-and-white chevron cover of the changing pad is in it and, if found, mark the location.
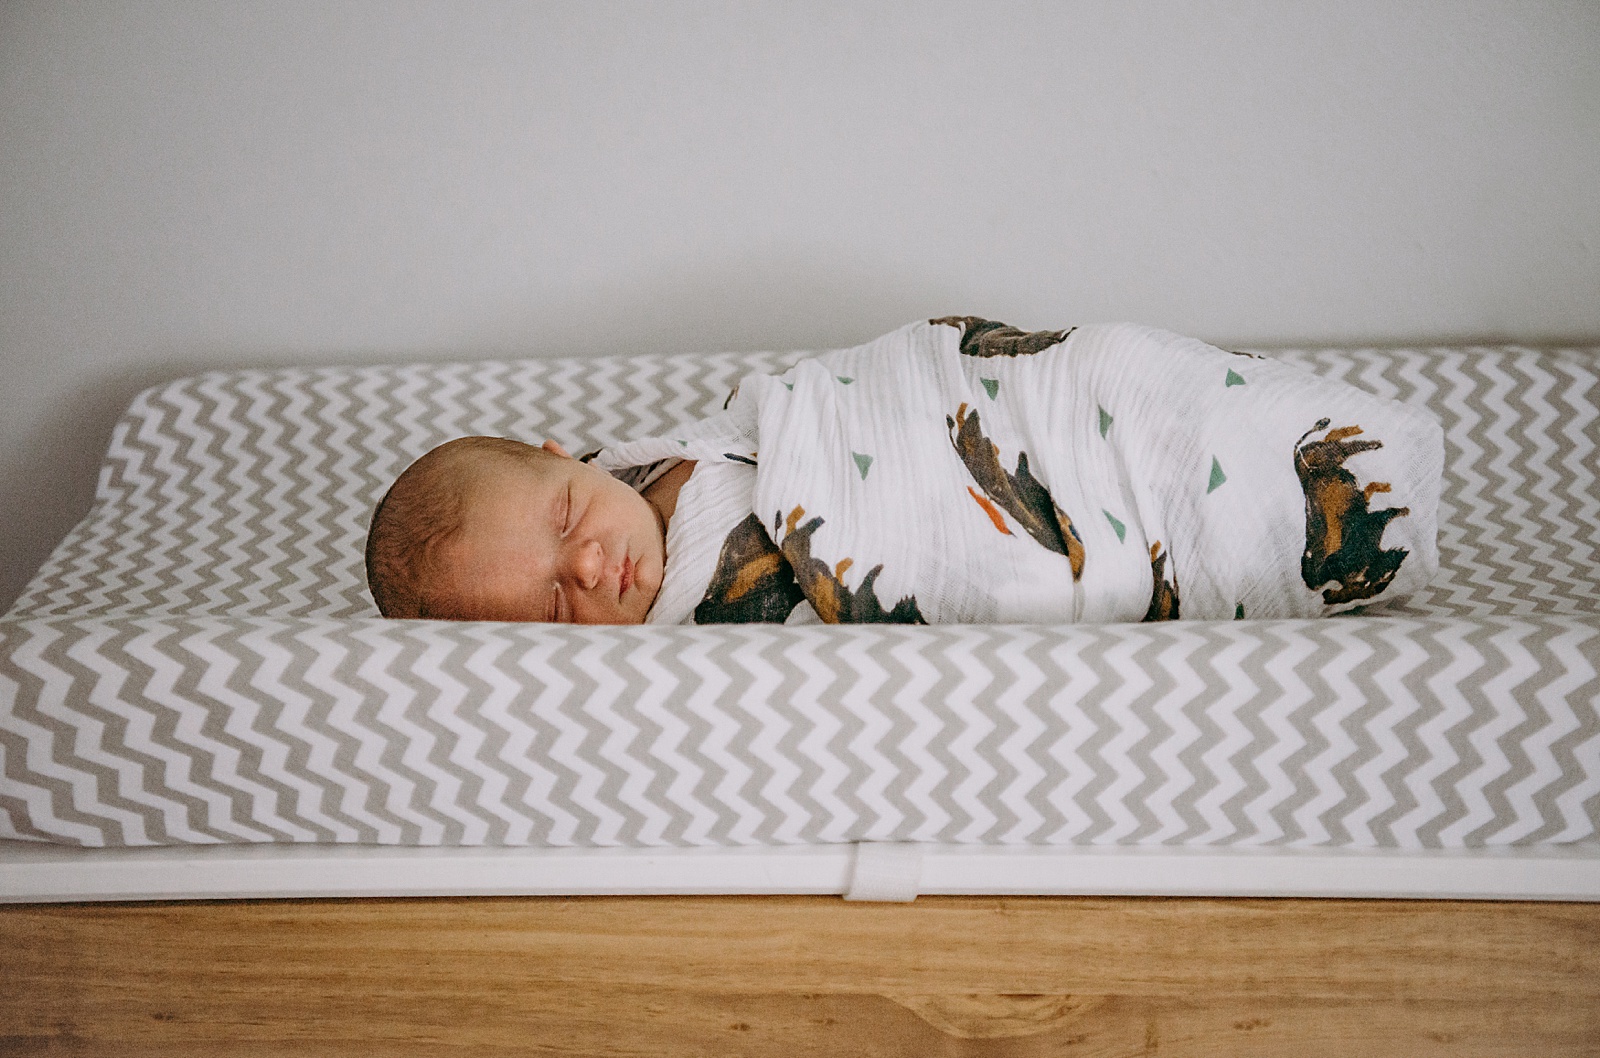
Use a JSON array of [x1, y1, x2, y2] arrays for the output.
[[0, 347, 1600, 848]]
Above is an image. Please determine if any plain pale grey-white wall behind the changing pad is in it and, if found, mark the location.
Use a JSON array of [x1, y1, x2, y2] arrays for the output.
[[0, 0, 1600, 608]]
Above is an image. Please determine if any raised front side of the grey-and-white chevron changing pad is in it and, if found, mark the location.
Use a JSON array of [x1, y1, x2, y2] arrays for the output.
[[0, 618, 1600, 848]]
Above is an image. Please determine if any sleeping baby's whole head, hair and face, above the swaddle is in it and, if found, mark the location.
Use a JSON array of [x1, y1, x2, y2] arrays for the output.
[[366, 437, 666, 624]]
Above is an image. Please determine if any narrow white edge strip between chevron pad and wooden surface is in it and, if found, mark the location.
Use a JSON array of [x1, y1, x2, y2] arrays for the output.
[[0, 842, 1600, 903]]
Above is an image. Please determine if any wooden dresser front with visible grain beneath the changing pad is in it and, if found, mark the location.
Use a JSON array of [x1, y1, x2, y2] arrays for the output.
[[0, 896, 1600, 1058]]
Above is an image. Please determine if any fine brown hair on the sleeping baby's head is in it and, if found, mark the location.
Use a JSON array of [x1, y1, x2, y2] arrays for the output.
[[366, 437, 554, 618]]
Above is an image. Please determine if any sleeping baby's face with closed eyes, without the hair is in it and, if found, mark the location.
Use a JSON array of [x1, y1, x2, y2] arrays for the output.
[[429, 445, 666, 624]]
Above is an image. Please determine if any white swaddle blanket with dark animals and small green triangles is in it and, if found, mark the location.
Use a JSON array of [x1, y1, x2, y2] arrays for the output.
[[598, 317, 1443, 624]]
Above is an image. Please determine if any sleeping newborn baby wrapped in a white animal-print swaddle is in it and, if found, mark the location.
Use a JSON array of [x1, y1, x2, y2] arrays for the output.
[[366, 317, 1443, 624]]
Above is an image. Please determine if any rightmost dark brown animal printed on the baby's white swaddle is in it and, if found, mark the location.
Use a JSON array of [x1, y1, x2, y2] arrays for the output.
[[1294, 419, 1411, 605]]
